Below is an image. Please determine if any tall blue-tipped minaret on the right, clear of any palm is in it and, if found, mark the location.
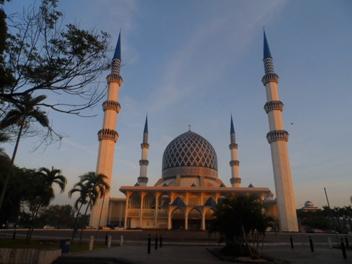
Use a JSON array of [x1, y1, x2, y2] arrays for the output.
[[262, 32, 298, 232]]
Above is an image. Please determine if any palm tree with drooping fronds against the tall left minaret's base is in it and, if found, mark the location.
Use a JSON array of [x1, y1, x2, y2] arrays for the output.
[[69, 172, 110, 240]]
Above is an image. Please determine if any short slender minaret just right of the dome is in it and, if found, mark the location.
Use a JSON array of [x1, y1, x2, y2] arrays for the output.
[[229, 116, 241, 187]]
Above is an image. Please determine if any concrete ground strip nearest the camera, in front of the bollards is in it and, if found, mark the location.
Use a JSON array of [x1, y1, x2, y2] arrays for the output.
[[72, 244, 352, 264]]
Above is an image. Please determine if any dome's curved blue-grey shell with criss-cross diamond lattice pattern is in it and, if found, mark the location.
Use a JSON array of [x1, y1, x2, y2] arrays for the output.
[[163, 131, 218, 171]]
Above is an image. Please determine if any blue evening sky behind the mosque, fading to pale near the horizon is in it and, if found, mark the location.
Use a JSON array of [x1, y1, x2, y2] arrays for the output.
[[2, 0, 352, 208]]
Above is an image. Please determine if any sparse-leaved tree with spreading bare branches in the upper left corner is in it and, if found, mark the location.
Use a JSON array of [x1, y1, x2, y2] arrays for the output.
[[0, 0, 109, 115]]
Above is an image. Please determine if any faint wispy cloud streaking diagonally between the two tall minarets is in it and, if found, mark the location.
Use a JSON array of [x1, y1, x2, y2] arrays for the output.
[[150, 1, 286, 111]]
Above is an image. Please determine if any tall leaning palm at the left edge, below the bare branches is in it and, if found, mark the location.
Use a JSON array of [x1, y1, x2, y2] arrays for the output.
[[0, 94, 49, 209]]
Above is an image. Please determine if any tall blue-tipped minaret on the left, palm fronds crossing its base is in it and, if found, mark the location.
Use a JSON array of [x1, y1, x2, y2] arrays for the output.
[[89, 33, 122, 227]]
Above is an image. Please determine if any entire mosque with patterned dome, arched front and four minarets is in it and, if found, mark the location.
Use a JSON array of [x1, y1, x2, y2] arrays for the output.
[[90, 32, 298, 231]]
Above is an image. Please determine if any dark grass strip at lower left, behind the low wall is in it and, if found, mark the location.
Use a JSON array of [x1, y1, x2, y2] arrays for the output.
[[0, 239, 106, 252]]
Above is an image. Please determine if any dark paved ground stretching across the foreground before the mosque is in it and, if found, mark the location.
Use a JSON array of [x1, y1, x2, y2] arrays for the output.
[[0, 230, 352, 264]]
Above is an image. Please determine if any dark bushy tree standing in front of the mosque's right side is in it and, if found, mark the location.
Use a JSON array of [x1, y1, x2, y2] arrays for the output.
[[211, 196, 272, 256]]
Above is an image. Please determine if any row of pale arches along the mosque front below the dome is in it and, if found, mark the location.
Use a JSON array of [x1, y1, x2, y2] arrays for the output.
[[121, 186, 269, 230]]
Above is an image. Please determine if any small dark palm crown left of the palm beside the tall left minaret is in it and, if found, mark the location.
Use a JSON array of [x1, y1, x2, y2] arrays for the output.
[[39, 167, 67, 199]]
